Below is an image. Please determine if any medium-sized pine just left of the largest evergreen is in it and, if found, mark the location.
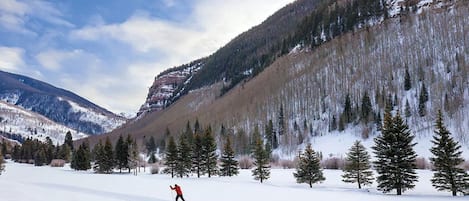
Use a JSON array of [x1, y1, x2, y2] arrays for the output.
[[342, 140, 373, 189]]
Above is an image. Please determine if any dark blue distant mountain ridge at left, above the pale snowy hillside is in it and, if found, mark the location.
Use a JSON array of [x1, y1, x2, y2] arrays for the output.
[[0, 71, 126, 135]]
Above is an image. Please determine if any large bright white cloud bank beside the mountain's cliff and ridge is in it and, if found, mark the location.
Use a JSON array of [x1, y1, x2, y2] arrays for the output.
[[59, 0, 293, 112]]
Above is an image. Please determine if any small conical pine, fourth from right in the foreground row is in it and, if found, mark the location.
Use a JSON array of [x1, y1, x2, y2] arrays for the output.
[[293, 144, 326, 188]]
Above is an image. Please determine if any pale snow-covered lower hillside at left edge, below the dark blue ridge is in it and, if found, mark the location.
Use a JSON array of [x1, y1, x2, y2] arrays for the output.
[[0, 101, 88, 145]]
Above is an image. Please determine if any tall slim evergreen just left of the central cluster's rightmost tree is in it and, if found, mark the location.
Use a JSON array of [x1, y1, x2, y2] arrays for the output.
[[202, 127, 218, 178]]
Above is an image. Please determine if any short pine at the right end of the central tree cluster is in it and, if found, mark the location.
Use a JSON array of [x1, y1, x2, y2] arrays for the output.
[[220, 137, 239, 177]]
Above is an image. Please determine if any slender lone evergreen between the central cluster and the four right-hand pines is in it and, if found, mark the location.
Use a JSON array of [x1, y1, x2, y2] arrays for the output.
[[252, 138, 270, 183]]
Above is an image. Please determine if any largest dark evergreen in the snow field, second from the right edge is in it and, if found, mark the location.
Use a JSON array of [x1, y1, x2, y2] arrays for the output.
[[373, 109, 418, 195]]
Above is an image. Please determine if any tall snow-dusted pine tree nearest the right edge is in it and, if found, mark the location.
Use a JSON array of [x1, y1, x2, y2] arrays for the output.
[[430, 110, 469, 196]]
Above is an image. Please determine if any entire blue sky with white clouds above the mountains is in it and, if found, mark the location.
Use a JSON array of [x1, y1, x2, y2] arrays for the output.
[[0, 0, 293, 113]]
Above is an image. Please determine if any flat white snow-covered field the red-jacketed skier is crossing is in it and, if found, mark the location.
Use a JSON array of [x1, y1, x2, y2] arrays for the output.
[[0, 161, 468, 201]]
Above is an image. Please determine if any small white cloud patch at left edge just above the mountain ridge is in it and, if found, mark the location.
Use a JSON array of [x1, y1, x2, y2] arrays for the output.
[[0, 46, 25, 72]]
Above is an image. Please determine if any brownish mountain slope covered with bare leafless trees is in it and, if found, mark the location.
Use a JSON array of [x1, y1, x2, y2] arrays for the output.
[[88, 1, 469, 156]]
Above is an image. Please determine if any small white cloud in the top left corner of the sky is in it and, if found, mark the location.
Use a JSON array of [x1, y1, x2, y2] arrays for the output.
[[0, 0, 74, 35]]
